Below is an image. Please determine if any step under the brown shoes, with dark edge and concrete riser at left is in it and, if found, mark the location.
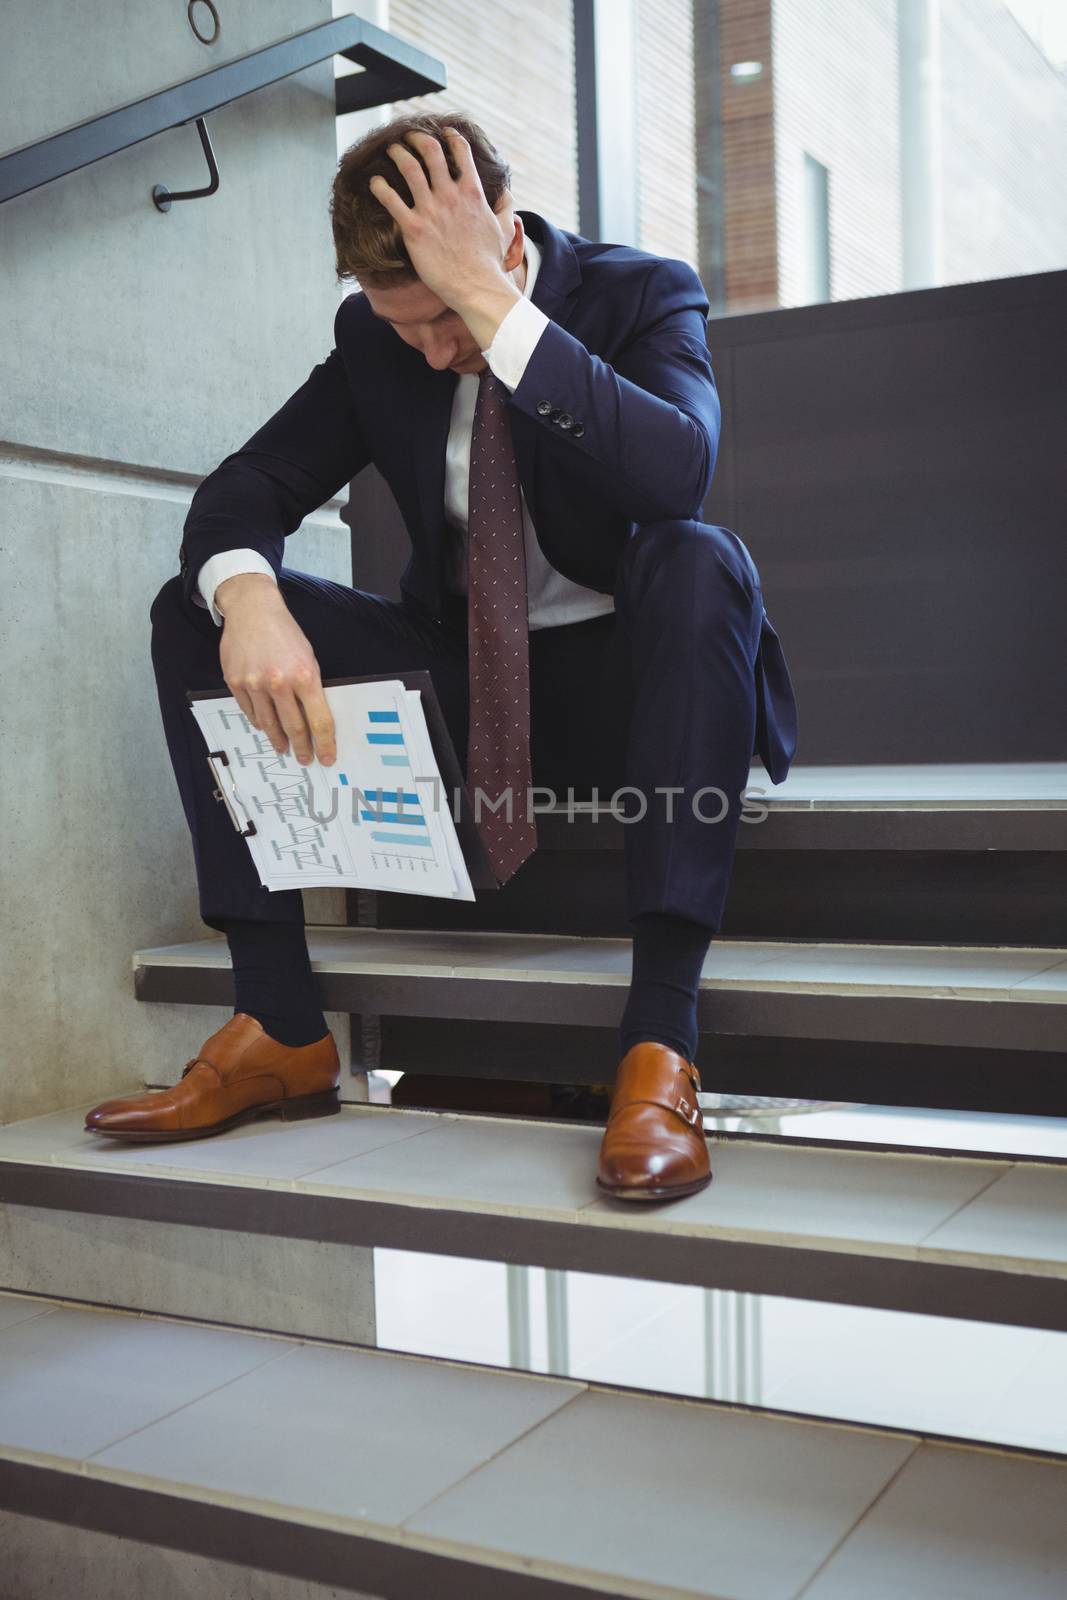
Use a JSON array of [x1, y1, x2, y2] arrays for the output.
[[0, 1106, 1067, 1342]]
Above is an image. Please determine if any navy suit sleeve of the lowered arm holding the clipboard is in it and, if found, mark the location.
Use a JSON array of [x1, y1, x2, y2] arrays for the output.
[[179, 302, 371, 600]]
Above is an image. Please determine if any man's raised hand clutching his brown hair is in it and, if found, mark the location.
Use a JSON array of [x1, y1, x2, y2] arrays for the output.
[[370, 128, 522, 349]]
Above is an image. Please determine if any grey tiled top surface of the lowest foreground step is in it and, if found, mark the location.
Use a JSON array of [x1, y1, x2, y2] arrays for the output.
[[0, 1298, 1067, 1600]]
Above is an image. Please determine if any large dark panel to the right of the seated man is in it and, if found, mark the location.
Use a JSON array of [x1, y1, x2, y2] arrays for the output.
[[705, 272, 1067, 763]]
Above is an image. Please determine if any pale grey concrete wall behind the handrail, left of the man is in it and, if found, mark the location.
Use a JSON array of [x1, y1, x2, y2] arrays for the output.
[[0, 0, 350, 1122]]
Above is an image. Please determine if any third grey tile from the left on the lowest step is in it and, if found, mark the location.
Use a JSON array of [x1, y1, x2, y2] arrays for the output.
[[403, 1394, 921, 1597]]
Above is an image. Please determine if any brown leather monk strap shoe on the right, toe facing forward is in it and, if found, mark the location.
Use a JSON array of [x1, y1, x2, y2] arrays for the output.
[[597, 1038, 712, 1200]]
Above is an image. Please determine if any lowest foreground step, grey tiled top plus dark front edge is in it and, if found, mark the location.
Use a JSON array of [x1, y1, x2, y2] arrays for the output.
[[0, 1296, 1067, 1600]]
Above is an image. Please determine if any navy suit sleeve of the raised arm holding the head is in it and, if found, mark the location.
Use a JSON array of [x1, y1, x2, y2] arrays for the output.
[[512, 258, 720, 522]]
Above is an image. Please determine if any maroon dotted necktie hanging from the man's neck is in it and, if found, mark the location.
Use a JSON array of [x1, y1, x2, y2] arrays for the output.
[[467, 366, 537, 883]]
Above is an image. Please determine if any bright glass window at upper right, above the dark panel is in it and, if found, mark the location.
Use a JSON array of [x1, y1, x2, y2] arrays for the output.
[[684, 0, 1067, 314]]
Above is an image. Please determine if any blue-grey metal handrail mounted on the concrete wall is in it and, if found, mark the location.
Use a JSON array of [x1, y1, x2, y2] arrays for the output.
[[0, 16, 446, 210]]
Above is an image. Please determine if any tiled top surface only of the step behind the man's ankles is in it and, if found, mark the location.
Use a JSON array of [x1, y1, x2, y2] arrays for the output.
[[133, 926, 1067, 1003]]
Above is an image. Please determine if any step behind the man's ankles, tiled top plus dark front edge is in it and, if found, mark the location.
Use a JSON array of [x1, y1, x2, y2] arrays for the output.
[[133, 926, 1067, 1062]]
